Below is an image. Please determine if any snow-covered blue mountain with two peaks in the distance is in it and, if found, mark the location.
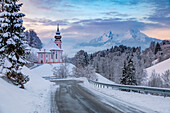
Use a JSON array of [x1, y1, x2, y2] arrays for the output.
[[78, 29, 161, 49]]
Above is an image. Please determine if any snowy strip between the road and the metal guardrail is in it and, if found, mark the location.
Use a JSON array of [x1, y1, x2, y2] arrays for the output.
[[82, 77, 170, 113]]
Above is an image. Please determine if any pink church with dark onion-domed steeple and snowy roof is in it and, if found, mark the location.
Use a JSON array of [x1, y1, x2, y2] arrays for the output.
[[38, 25, 63, 64]]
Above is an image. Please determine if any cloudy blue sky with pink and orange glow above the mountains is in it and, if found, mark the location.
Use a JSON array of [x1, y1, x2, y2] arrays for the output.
[[20, 0, 170, 56]]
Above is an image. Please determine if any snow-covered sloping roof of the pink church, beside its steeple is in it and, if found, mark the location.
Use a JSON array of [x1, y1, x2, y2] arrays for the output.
[[39, 39, 62, 52]]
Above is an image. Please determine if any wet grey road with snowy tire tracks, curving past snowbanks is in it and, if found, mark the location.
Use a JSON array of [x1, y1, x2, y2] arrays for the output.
[[52, 80, 154, 113]]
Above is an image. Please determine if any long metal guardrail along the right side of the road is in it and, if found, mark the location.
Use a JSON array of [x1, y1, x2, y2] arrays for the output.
[[88, 80, 170, 97]]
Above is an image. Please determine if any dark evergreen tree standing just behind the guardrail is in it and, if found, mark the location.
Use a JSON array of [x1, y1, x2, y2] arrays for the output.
[[120, 57, 137, 85]]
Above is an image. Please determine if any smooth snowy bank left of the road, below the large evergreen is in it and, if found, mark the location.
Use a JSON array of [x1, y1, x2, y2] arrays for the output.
[[0, 67, 53, 113]]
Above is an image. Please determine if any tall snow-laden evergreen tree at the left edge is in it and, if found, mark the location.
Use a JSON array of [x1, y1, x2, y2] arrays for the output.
[[0, 0, 29, 88]]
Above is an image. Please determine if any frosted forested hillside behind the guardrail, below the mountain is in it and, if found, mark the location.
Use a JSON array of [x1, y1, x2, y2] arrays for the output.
[[71, 41, 170, 85]]
